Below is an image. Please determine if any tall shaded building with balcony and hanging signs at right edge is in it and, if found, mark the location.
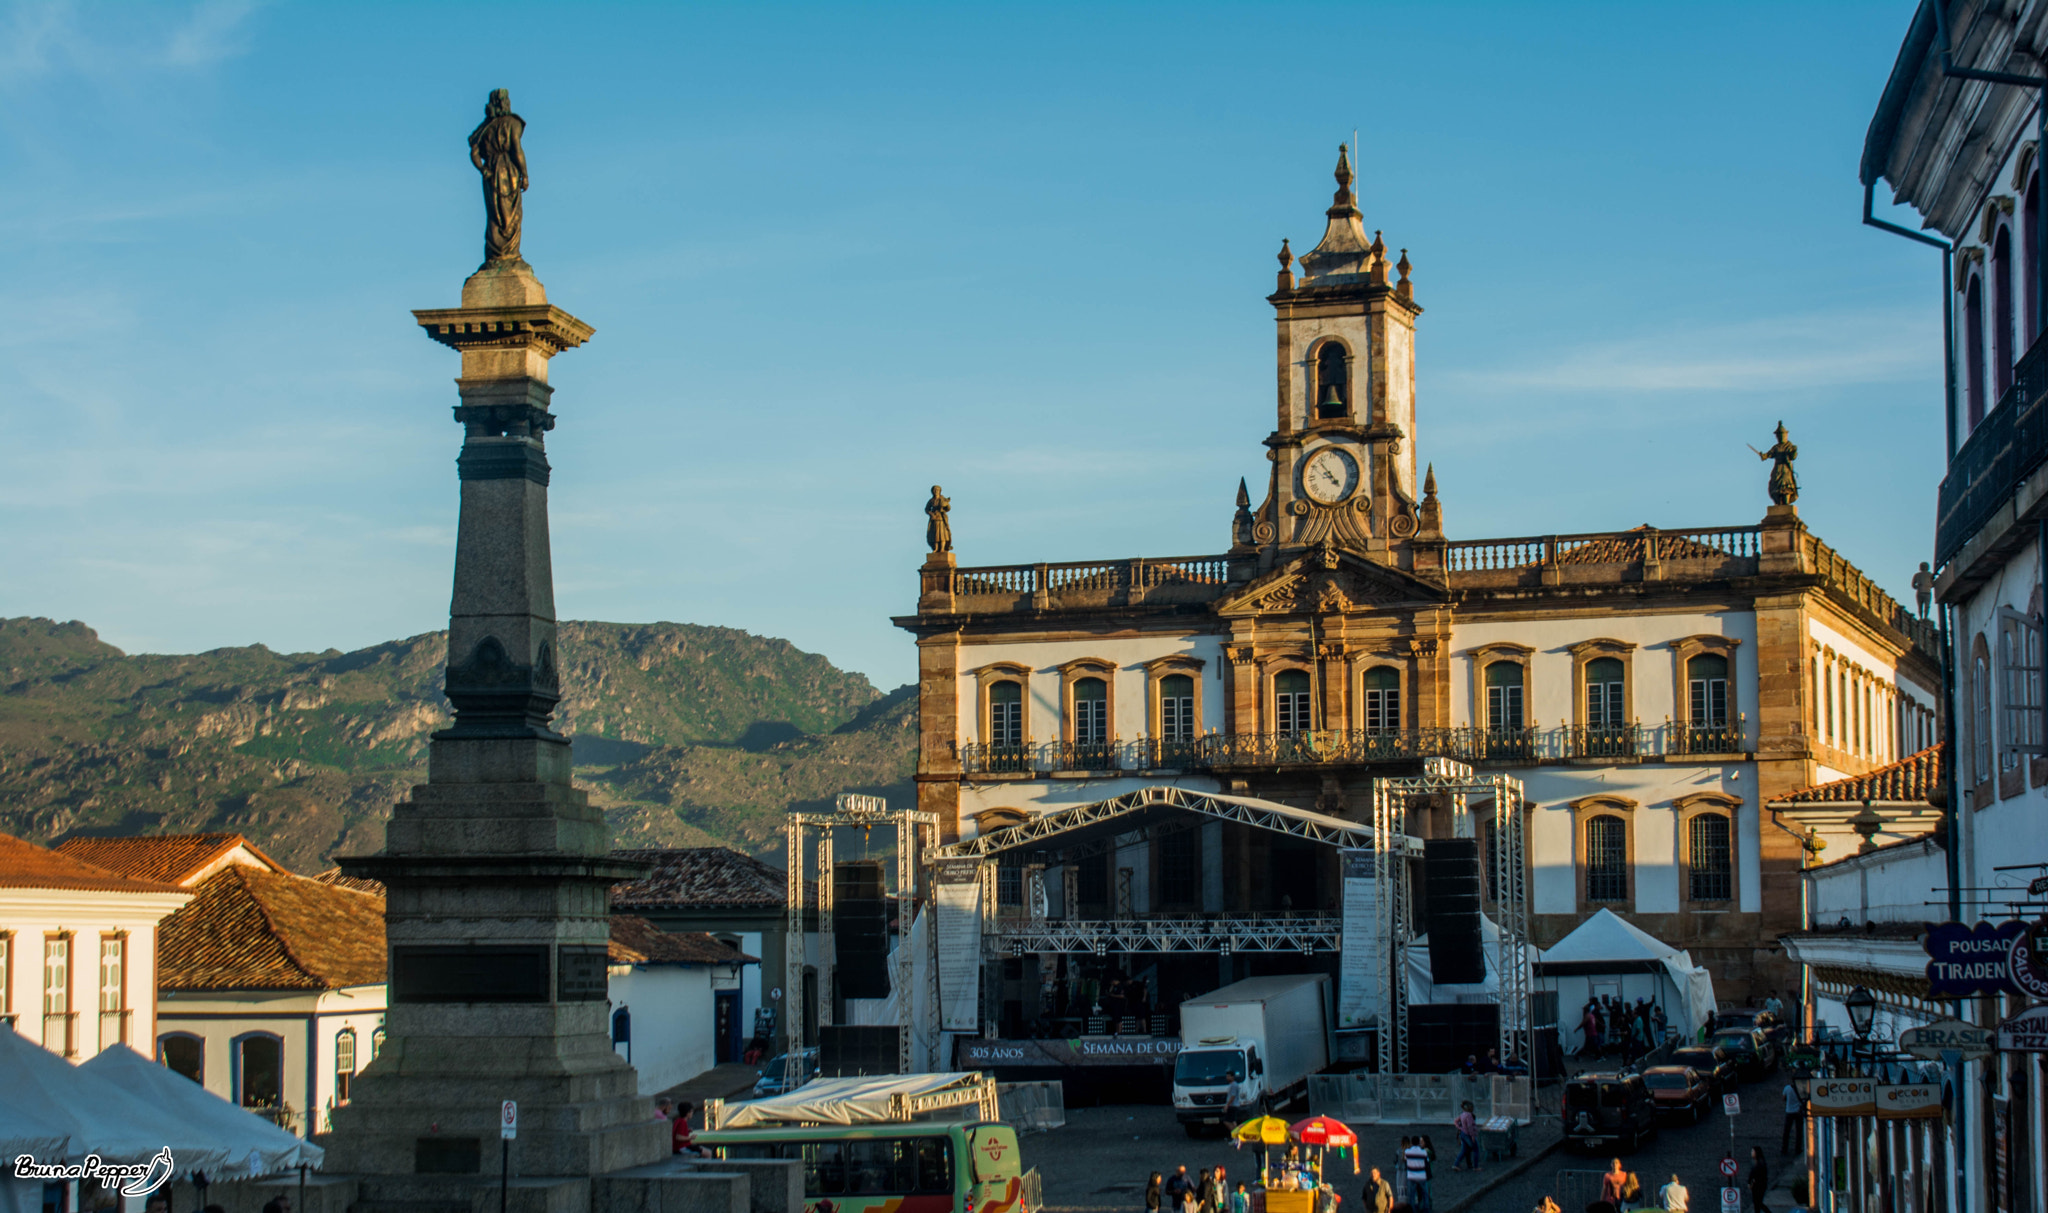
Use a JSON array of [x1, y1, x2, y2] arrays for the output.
[[1867, 0, 2048, 1209]]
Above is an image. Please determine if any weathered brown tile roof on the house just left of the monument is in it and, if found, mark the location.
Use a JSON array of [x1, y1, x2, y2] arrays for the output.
[[156, 863, 385, 990]]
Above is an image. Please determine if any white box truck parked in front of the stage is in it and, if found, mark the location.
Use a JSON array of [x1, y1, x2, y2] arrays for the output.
[[1174, 973, 1329, 1137]]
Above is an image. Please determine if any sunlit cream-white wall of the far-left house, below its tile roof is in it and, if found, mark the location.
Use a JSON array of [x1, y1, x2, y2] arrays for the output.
[[0, 889, 193, 1061]]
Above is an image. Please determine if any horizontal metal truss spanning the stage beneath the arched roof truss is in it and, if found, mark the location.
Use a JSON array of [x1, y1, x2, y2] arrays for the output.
[[991, 914, 1343, 957]]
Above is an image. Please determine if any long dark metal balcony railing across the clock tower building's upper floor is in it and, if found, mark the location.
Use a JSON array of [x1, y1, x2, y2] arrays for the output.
[[958, 715, 1749, 775]]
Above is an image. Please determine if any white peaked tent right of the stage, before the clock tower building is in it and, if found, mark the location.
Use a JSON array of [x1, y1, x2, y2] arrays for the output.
[[1536, 910, 1714, 1053]]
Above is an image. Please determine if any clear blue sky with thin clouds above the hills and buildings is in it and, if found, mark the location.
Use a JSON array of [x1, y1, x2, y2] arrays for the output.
[[0, 0, 1942, 686]]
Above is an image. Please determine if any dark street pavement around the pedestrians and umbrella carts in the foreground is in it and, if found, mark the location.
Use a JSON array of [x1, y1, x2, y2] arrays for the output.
[[1024, 1072, 1802, 1213]]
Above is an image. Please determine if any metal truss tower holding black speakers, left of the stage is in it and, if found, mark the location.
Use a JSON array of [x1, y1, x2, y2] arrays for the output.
[[782, 793, 938, 1090]]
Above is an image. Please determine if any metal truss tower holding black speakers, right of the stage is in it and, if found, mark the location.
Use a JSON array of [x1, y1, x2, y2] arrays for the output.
[[1370, 758, 1534, 1074]]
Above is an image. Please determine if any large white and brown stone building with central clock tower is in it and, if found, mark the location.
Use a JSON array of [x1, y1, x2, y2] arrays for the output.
[[897, 144, 1939, 1035]]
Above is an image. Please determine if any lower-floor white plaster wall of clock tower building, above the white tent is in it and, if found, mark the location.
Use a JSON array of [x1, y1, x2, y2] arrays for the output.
[[1509, 762, 1763, 914]]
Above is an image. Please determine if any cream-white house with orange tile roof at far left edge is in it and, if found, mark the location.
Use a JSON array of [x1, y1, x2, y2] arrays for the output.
[[0, 834, 193, 1061]]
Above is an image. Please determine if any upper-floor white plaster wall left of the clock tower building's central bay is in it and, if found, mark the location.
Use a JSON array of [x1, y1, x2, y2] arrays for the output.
[[956, 633, 1225, 744]]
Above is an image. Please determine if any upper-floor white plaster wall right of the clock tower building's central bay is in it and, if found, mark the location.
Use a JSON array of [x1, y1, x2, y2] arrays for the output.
[[1450, 611, 1757, 740]]
